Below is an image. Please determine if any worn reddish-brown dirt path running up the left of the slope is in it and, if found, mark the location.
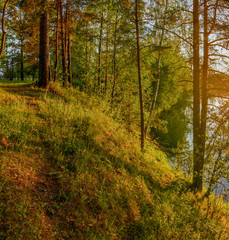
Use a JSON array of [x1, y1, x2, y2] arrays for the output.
[[0, 85, 61, 239]]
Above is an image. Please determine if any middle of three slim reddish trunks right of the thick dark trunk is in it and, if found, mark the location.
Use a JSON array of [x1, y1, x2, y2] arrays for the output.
[[60, 0, 67, 86]]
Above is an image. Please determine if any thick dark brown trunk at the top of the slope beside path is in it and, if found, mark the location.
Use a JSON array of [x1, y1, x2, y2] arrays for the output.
[[38, 0, 50, 88]]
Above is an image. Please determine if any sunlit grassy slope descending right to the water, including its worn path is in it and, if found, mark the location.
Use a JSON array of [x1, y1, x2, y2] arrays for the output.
[[0, 81, 229, 240]]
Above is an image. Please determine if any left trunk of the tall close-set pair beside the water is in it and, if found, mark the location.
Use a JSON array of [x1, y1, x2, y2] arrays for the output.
[[193, 0, 203, 192]]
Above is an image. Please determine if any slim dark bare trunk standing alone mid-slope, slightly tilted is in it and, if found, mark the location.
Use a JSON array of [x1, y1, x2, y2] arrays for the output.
[[135, 0, 145, 150]]
